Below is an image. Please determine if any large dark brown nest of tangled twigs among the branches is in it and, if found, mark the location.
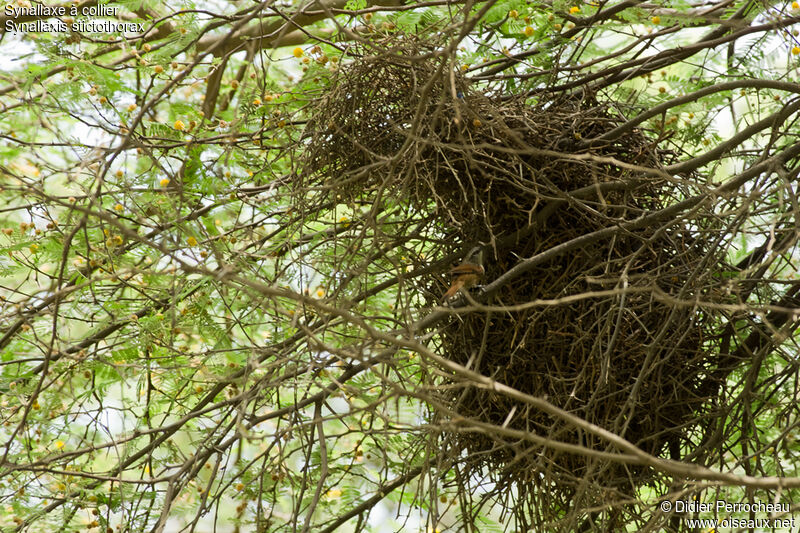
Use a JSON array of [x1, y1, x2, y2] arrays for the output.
[[303, 36, 723, 526]]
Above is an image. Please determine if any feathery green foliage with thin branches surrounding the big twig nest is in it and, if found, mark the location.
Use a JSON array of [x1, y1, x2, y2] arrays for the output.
[[0, 0, 800, 531]]
